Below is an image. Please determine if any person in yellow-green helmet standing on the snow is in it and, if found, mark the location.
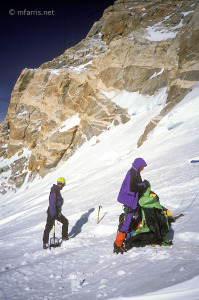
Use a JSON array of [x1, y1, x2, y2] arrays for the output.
[[43, 177, 68, 249]]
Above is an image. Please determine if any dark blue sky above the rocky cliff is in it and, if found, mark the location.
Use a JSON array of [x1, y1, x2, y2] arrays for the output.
[[0, 0, 114, 122]]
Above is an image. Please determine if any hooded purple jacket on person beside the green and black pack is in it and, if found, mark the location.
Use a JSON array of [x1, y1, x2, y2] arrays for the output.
[[117, 158, 147, 210]]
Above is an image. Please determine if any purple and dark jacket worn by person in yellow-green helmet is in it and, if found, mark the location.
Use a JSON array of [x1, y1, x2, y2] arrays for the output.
[[49, 184, 64, 218]]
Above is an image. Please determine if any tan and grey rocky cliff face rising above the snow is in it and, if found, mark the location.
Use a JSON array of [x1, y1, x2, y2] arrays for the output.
[[0, 0, 199, 193]]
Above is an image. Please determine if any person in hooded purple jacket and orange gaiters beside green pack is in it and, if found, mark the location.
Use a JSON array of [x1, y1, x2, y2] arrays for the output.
[[114, 158, 148, 253]]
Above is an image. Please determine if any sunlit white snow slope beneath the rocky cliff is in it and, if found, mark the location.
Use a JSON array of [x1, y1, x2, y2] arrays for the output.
[[0, 86, 199, 300]]
